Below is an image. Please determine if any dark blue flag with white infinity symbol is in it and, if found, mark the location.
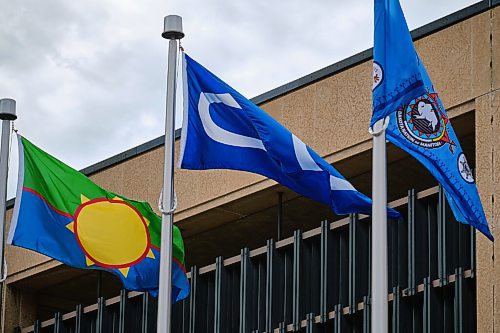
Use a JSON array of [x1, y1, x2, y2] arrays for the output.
[[179, 54, 399, 217]]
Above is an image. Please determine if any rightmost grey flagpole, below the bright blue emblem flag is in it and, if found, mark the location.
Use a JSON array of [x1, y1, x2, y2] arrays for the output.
[[370, 117, 389, 332]]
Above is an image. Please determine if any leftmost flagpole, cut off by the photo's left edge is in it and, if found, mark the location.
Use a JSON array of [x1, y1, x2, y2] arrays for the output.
[[0, 98, 17, 278]]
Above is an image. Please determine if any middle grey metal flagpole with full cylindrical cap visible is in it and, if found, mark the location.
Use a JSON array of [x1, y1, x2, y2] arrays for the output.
[[157, 15, 184, 333]]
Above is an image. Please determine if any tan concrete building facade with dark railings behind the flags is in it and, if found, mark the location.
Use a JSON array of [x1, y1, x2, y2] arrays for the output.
[[1, 0, 500, 332]]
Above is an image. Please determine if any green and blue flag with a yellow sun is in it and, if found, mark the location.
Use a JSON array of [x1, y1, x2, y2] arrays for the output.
[[7, 135, 190, 302]]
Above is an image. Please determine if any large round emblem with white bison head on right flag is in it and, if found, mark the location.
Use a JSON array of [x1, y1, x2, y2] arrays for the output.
[[396, 93, 455, 153]]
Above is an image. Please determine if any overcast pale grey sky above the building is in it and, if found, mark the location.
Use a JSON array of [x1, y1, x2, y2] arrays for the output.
[[0, 0, 477, 199]]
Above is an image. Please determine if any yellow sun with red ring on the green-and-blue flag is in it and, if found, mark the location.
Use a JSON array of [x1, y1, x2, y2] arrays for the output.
[[66, 195, 155, 277]]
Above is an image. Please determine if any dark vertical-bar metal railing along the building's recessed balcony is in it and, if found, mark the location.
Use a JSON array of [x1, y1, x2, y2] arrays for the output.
[[17, 187, 476, 333]]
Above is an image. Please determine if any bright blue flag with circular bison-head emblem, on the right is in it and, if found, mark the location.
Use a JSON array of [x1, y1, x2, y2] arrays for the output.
[[371, 0, 493, 240]]
